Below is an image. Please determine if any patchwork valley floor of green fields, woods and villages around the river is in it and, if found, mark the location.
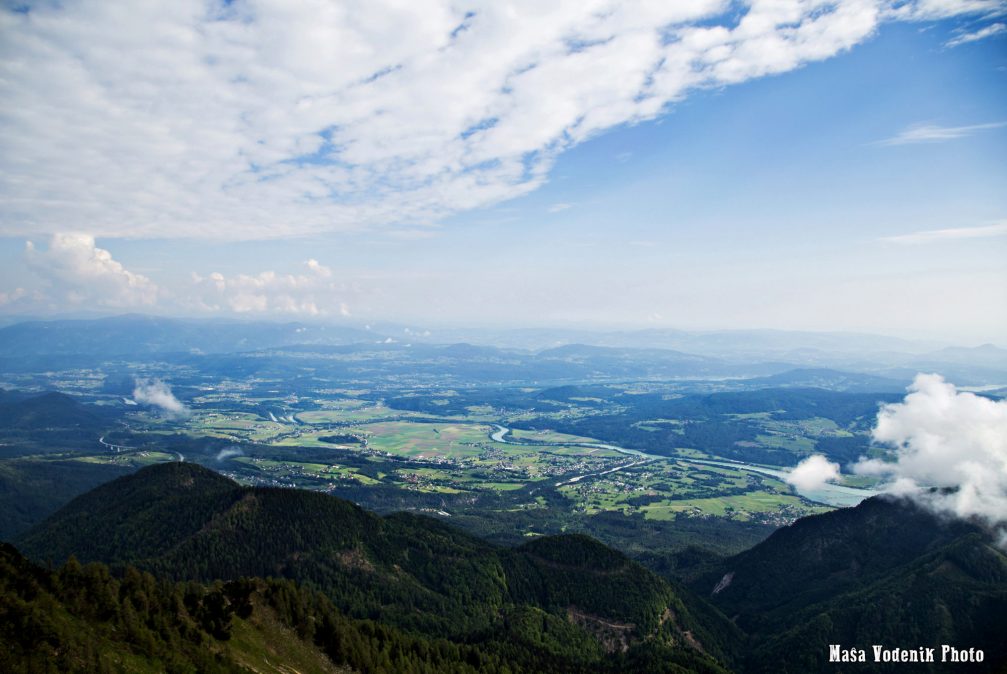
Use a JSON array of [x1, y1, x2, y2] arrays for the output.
[[0, 360, 898, 550]]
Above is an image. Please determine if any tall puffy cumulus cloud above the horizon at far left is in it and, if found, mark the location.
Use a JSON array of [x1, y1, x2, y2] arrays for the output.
[[25, 234, 158, 308]]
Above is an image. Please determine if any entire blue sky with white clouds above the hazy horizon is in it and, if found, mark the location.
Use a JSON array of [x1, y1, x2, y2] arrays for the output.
[[0, 0, 1007, 347]]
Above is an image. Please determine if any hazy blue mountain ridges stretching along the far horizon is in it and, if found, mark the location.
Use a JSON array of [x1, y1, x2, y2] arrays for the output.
[[0, 314, 1007, 386]]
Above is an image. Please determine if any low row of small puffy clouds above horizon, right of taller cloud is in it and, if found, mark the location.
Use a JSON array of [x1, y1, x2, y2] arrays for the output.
[[189, 260, 353, 316]]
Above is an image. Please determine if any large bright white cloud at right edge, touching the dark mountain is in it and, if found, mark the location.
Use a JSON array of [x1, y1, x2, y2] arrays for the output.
[[855, 374, 1007, 527]]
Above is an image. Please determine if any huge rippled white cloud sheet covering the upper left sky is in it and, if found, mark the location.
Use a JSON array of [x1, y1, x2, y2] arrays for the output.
[[0, 0, 990, 240]]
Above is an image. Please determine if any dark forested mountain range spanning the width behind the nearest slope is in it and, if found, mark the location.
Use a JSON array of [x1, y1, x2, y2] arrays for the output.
[[9, 463, 1007, 672]]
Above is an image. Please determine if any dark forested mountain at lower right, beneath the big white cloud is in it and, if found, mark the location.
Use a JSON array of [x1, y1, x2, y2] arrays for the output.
[[692, 497, 1007, 672]]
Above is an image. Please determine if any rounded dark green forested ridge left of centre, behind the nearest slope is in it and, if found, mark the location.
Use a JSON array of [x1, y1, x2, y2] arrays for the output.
[[19, 463, 734, 671]]
